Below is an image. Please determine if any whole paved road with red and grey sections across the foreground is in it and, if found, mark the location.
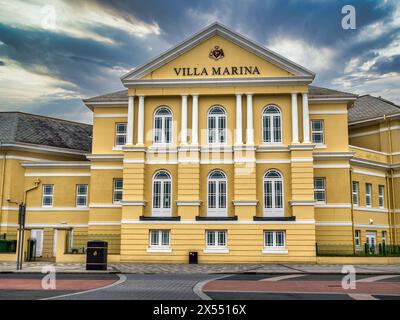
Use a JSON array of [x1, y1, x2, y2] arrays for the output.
[[0, 273, 400, 300]]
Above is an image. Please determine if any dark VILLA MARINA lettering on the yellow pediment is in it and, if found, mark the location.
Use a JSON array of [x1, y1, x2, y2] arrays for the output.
[[174, 66, 261, 77]]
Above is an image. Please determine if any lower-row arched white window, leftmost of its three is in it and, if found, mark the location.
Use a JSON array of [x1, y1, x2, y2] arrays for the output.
[[153, 171, 172, 216]]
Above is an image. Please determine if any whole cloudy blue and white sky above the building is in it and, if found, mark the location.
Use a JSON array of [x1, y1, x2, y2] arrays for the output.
[[0, 0, 400, 123]]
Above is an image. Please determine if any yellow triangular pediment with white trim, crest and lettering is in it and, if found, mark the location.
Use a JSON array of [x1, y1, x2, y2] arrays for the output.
[[121, 23, 315, 83]]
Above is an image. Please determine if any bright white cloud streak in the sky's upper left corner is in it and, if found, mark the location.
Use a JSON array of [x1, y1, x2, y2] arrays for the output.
[[0, 0, 161, 44]]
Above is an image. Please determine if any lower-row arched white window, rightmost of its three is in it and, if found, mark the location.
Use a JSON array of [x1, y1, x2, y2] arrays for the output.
[[264, 170, 283, 216]]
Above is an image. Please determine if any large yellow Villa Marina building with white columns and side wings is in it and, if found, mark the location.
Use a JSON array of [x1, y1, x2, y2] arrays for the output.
[[0, 23, 400, 263]]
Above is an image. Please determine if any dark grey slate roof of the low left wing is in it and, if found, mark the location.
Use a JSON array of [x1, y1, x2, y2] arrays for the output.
[[0, 112, 92, 152]]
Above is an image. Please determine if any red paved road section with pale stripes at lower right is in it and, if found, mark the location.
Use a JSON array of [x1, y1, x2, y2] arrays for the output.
[[202, 273, 400, 300]]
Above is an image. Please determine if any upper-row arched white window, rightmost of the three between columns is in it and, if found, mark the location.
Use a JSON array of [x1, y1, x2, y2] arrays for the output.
[[263, 106, 282, 143]]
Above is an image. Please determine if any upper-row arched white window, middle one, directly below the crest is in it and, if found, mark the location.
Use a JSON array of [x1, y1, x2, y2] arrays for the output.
[[207, 106, 226, 144]]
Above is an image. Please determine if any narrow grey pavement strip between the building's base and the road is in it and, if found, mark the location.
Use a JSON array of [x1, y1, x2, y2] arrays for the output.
[[0, 262, 400, 274]]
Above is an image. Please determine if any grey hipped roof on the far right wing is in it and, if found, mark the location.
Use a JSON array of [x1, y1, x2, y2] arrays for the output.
[[349, 95, 400, 123]]
